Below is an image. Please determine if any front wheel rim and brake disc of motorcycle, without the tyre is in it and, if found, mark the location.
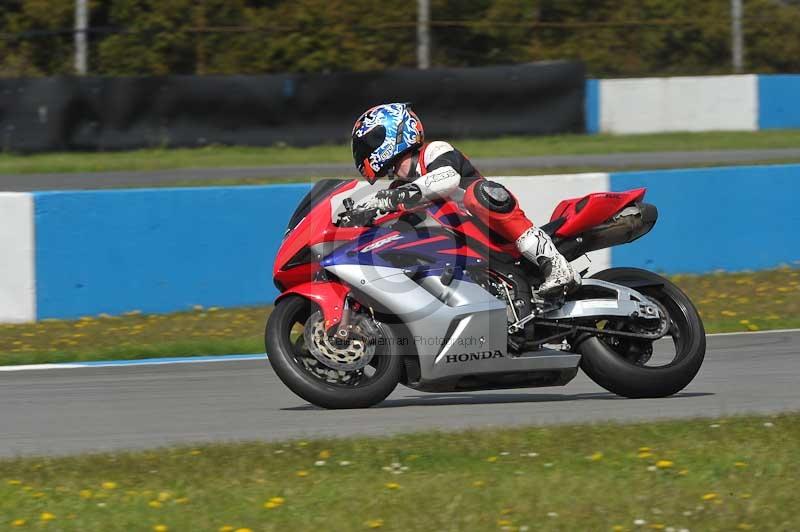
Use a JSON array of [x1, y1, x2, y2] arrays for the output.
[[285, 308, 390, 389]]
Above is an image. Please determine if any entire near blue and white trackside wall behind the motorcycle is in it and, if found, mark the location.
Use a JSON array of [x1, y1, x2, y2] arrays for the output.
[[0, 165, 800, 322]]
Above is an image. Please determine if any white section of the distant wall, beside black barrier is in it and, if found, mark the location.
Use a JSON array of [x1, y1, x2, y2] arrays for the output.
[[599, 75, 759, 133]]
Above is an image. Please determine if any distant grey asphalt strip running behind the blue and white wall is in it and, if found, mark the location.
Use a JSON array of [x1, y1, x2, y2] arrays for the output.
[[0, 148, 800, 192]]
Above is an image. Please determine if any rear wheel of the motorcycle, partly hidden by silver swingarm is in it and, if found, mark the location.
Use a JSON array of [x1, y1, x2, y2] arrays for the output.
[[579, 268, 706, 398]]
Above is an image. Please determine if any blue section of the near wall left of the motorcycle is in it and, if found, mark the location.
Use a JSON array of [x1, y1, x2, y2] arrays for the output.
[[35, 184, 310, 319]]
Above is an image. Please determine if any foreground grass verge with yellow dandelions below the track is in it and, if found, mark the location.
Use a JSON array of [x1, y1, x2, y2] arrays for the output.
[[0, 416, 800, 532]]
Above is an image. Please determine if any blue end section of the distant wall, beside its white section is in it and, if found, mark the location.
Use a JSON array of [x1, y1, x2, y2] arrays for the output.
[[758, 75, 800, 129]]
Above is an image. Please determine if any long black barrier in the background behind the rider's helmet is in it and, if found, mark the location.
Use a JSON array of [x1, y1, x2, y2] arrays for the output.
[[0, 62, 585, 152]]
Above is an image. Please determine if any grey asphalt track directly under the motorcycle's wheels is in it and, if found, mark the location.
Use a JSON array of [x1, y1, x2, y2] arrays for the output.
[[0, 331, 800, 456]]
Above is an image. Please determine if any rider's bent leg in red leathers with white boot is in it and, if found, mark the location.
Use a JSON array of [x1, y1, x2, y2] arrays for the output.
[[464, 179, 580, 294]]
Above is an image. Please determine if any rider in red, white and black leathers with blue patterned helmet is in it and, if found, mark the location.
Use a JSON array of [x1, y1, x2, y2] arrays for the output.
[[352, 103, 581, 296]]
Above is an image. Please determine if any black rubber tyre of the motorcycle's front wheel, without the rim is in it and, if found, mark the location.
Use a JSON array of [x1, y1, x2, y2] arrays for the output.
[[264, 295, 403, 409]]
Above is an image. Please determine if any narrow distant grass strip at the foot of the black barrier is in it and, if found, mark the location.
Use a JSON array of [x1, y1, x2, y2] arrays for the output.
[[0, 130, 800, 174]]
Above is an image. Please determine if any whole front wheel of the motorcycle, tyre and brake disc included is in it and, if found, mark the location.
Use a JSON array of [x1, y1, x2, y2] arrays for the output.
[[264, 296, 403, 409]]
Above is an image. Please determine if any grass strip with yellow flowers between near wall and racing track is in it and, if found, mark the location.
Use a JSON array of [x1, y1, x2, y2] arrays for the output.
[[0, 268, 800, 365]]
